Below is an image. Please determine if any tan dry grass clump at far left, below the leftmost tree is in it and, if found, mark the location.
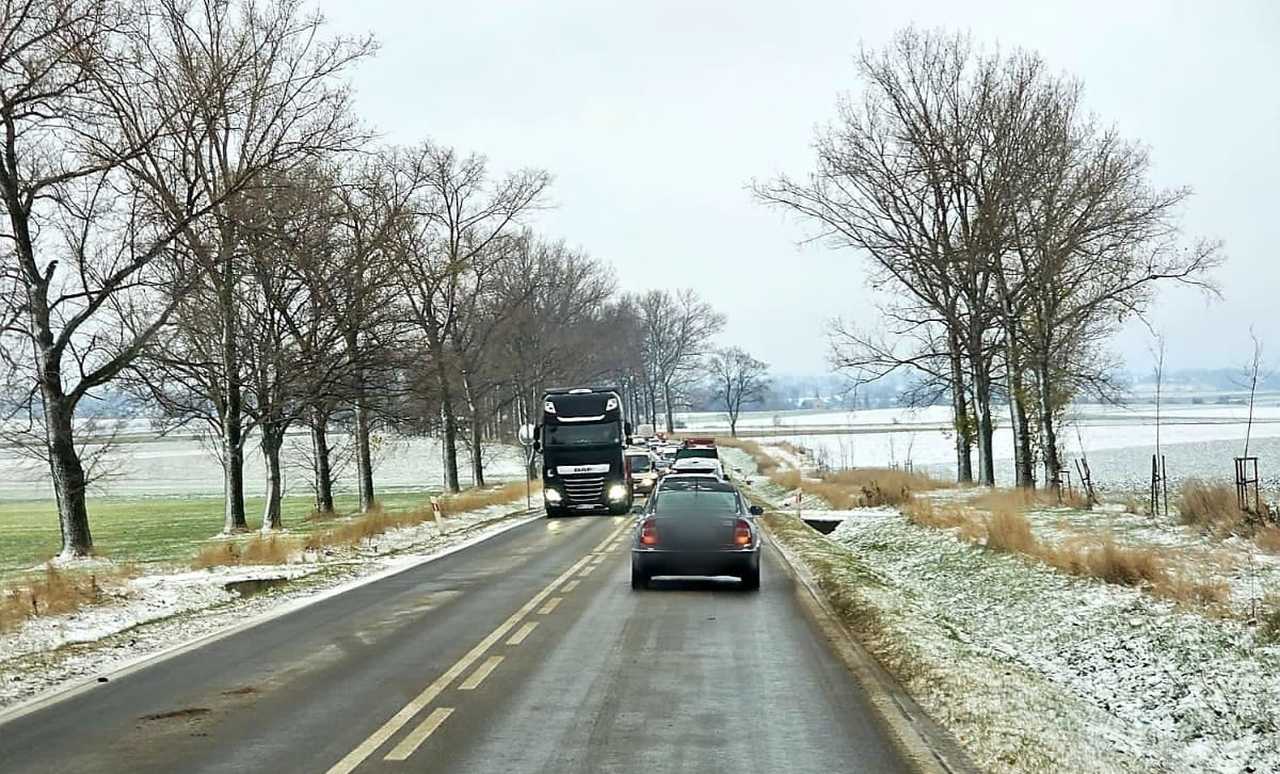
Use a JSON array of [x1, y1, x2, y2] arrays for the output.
[[0, 564, 140, 632]]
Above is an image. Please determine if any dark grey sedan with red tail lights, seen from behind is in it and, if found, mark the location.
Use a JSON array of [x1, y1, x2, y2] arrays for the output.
[[631, 476, 760, 591]]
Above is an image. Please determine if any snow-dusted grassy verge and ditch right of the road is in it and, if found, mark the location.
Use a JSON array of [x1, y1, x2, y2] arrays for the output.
[[730, 446, 1280, 771]]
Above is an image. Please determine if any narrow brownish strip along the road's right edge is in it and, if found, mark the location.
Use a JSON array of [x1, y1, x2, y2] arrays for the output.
[[758, 521, 979, 774]]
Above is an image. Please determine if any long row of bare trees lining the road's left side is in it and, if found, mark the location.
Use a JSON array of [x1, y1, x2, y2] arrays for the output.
[[0, 0, 763, 555]]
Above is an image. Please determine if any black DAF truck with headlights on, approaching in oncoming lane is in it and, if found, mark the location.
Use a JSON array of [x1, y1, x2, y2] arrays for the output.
[[534, 388, 631, 516]]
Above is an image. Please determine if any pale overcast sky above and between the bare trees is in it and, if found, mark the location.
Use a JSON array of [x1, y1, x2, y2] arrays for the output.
[[319, 0, 1280, 372]]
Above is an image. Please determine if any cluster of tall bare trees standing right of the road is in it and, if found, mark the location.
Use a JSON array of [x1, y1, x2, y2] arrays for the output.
[[755, 28, 1222, 487]]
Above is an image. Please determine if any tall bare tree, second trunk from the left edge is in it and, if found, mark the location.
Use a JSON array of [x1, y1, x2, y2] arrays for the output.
[[118, 0, 372, 531]]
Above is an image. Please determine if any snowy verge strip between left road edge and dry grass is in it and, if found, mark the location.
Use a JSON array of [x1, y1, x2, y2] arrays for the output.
[[0, 504, 525, 709]]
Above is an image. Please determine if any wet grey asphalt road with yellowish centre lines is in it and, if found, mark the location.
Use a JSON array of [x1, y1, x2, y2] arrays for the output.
[[0, 509, 910, 774]]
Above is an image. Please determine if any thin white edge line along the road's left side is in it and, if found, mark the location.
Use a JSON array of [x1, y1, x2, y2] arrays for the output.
[[0, 509, 543, 728]]
